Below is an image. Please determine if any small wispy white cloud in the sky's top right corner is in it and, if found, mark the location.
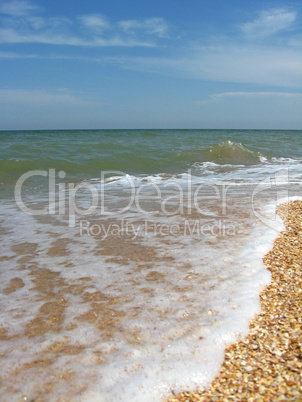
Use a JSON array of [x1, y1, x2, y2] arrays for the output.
[[241, 8, 297, 37]]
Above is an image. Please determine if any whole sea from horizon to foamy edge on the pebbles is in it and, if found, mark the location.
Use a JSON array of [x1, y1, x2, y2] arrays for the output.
[[0, 130, 302, 402]]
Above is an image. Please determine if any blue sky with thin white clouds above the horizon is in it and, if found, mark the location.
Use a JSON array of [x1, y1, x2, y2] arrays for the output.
[[0, 0, 302, 130]]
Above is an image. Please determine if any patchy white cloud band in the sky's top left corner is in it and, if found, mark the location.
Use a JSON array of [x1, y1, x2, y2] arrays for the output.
[[0, 0, 168, 47]]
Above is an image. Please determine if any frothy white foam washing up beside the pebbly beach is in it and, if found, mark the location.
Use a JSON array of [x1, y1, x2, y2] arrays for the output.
[[0, 181, 302, 402]]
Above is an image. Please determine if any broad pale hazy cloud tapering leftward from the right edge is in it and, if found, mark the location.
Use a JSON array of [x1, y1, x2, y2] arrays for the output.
[[103, 44, 302, 88]]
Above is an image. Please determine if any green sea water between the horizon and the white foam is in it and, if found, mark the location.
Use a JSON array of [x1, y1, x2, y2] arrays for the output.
[[0, 130, 302, 184]]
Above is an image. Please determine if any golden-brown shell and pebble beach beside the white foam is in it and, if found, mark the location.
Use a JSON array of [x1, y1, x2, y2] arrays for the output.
[[166, 201, 302, 402]]
